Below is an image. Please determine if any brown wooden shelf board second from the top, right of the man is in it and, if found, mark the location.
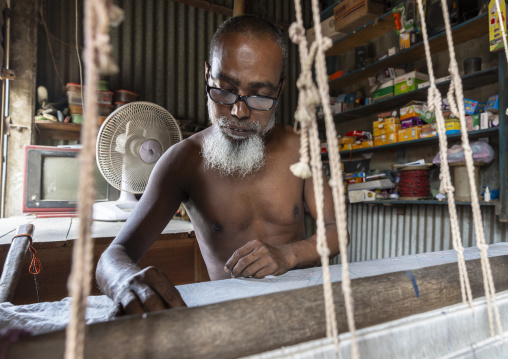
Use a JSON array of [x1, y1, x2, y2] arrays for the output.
[[328, 13, 489, 90]]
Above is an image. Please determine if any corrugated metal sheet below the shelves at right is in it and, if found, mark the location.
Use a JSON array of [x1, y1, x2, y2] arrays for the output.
[[342, 204, 508, 262]]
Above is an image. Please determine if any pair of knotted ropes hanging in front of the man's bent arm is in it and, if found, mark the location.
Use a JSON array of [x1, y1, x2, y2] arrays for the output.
[[289, 0, 359, 358]]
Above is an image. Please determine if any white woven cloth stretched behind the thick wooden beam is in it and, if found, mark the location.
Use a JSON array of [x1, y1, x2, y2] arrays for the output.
[[0, 243, 508, 334]]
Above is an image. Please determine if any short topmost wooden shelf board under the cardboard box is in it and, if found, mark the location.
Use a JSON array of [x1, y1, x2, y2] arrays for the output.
[[326, 11, 395, 56]]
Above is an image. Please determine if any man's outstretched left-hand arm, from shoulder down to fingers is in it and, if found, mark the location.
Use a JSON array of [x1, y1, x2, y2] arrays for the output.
[[96, 146, 189, 314]]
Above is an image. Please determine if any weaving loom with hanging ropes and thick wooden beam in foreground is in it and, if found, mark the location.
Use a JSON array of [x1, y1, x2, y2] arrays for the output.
[[0, 0, 508, 358]]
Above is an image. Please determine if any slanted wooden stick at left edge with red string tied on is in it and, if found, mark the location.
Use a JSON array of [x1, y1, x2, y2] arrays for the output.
[[0, 224, 34, 303]]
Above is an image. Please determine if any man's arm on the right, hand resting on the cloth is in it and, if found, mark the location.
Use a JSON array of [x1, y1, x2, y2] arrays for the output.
[[224, 173, 349, 278]]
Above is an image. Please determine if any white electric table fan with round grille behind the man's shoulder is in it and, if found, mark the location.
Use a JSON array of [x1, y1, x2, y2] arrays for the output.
[[93, 102, 182, 221]]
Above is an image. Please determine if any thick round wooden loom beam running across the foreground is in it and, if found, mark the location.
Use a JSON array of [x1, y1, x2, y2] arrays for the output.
[[8, 256, 508, 359]]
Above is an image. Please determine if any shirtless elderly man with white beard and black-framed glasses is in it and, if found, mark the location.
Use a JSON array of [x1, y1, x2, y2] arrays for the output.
[[97, 16, 339, 313]]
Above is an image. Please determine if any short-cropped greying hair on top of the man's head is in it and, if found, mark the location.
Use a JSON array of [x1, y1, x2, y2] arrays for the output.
[[208, 15, 288, 78]]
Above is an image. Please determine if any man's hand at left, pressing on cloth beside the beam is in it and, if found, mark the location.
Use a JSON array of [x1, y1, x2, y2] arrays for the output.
[[115, 267, 187, 316]]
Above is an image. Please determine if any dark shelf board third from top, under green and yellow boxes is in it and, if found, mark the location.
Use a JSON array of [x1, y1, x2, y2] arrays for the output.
[[333, 67, 498, 123]]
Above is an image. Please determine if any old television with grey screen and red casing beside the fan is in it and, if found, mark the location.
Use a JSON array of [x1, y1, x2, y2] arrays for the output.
[[23, 145, 120, 216]]
